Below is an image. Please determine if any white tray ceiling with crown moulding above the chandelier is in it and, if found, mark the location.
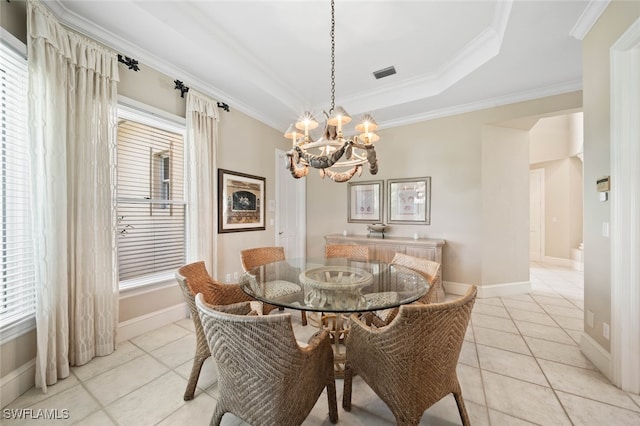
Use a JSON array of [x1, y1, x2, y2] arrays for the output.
[[47, 0, 608, 131]]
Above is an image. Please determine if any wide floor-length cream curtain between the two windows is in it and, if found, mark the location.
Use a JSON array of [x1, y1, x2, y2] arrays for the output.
[[27, 0, 118, 392]]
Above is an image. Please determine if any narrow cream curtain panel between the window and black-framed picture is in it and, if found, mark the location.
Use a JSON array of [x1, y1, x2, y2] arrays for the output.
[[185, 89, 218, 278]]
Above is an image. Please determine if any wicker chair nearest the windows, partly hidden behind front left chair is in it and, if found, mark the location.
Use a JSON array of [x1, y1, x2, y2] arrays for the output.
[[175, 262, 275, 401]]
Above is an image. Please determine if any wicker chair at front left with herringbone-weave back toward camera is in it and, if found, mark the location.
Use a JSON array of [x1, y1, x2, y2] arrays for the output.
[[196, 295, 338, 426]]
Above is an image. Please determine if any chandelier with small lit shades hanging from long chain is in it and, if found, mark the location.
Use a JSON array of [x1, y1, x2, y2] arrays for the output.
[[284, 0, 380, 182]]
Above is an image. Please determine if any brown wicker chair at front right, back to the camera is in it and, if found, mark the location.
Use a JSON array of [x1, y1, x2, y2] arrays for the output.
[[342, 286, 477, 425]]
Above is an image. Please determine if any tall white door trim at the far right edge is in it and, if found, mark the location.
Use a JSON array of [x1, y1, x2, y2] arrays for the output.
[[610, 19, 640, 394]]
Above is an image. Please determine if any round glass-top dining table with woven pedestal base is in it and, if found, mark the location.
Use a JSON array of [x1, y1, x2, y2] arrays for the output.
[[240, 258, 429, 377]]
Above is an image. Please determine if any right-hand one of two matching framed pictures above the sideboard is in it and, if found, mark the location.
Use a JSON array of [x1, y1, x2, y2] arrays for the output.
[[387, 176, 431, 225]]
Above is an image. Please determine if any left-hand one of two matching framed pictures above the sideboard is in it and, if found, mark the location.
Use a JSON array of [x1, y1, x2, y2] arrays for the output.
[[347, 180, 383, 223]]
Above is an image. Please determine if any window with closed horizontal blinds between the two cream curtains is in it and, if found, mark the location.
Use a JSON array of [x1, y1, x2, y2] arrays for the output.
[[117, 107, 186, 288]]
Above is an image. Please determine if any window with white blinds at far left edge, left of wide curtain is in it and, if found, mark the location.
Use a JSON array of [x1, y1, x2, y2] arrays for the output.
[[0, 39, 36, 338]]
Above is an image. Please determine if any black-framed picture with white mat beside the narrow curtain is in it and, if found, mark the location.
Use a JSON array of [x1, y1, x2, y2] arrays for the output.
[[218, 169, 265, 234]]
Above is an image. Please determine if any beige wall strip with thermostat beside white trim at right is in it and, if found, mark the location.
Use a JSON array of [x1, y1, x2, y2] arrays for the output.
[[582, 0, 640, 351]]
